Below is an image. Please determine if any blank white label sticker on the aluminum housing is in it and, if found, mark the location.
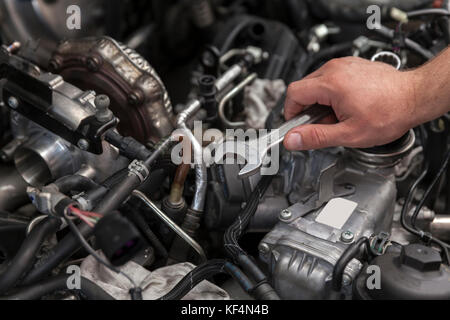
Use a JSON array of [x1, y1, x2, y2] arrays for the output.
[[316, 198, 358, 229]]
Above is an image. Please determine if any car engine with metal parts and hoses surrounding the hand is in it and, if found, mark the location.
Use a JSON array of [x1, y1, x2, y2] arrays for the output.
[[0, 0, 450, 300]]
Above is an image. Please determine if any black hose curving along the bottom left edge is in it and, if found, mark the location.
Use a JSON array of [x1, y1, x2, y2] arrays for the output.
[[0, 275, 114, 300]]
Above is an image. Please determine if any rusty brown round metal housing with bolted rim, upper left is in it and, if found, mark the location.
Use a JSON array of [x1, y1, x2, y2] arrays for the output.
[[49, 37, 174, 143]]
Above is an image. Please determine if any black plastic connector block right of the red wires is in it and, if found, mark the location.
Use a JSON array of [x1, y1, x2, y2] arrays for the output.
[[94, 212, 143, 266]]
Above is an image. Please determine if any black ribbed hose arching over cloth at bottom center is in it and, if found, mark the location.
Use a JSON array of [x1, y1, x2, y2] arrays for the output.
[[159, 260, 253, 300]]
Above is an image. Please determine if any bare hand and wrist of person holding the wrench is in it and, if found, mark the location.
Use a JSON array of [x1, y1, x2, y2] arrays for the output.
[[284, 48, 450, 150]]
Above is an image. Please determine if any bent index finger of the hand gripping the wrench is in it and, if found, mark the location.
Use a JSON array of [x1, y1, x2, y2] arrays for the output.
[[284, 76, 330, 120]]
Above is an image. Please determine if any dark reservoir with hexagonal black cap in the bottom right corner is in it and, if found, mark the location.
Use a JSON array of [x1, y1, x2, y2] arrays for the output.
[[354, 244, 450, 300]]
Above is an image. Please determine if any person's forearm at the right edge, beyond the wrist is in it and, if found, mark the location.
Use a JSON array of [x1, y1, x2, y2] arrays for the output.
[[412, 48, 450, 124]]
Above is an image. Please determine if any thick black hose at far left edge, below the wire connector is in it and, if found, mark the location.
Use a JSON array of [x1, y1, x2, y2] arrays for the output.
[[0, 217, 61, 294]]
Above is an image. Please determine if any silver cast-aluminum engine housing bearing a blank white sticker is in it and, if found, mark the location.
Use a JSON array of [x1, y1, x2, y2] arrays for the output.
[[259, 142, 414, 299]]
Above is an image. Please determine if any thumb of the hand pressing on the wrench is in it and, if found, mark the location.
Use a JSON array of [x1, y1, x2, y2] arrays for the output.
[[284, 122, 350, 150]]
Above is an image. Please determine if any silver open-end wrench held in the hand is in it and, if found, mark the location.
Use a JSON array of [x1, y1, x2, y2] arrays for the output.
[[215, 105, 333, 179]]
